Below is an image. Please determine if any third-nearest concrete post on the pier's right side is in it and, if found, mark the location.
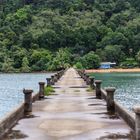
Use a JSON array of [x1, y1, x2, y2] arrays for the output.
[[95, 80, 102, 99]]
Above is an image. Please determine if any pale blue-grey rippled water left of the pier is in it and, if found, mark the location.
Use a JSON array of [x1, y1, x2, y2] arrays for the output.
[[0, 73, 52, 118]]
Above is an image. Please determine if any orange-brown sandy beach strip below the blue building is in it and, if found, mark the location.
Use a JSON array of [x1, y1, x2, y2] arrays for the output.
[[85, 68, 140, 73]]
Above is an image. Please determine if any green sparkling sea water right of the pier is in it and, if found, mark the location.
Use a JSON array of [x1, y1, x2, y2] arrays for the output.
[[91, 73, 140, 110]]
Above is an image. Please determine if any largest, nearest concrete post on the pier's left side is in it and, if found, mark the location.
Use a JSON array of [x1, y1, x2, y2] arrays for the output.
[[23, 89, 33, 115]]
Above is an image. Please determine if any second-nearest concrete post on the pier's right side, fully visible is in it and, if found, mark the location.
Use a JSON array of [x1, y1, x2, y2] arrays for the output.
[[106, 87, 116, 113]]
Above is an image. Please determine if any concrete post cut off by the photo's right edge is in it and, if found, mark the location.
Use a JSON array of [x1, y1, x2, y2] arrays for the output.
[[133, 106, 140, 140]]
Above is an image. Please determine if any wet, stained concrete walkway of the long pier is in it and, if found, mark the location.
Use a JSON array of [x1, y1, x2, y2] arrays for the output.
[[4, 69, 134, 140]]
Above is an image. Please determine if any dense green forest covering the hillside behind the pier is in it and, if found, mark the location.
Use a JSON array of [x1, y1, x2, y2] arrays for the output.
[[0, 0, 140, 72]]
